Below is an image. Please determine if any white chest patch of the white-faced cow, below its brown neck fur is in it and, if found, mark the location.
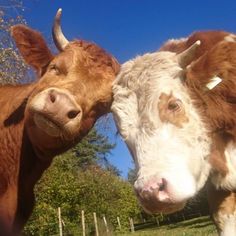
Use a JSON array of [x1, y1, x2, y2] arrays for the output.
[[211, 142, 236, 191]]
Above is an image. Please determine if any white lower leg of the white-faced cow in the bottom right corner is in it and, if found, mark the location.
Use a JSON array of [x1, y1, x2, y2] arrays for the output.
[[217, 213, 236, 236]]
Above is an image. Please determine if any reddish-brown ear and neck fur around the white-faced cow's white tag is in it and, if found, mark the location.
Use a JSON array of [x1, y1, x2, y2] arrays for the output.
[[186, 41, 236, 172]]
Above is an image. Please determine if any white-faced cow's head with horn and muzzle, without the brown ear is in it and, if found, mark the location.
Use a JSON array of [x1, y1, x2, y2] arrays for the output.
[[112, 41, 211, 213]]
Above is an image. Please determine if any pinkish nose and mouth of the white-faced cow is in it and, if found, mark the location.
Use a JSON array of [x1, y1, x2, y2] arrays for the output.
[[135, 178, 185, 214]]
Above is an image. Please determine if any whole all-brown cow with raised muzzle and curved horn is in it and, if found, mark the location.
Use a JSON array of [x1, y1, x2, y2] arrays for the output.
[[0, 10, 119, 236]]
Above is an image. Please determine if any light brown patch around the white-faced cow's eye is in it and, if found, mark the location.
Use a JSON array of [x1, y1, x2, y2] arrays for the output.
[[158, 93, 189, 128]]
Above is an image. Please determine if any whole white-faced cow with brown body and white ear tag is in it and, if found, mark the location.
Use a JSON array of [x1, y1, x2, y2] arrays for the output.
[[112, 31, 236, 235]]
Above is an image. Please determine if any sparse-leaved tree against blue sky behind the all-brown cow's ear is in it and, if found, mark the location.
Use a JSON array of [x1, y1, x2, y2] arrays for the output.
[[0, 0, 29, 84]]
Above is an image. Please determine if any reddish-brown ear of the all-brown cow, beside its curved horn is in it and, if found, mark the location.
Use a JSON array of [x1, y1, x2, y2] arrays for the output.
[[11, 25, 53, 75]]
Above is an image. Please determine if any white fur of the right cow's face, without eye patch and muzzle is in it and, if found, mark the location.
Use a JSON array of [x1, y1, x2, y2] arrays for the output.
[[112, 51, 211, 205]]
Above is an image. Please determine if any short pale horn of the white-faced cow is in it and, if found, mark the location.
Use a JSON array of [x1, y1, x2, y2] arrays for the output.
[[177, 40, 201, 69]]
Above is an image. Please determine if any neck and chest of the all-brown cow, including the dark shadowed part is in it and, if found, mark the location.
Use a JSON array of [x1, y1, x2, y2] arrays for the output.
[[0, 84, 54, 235]]
